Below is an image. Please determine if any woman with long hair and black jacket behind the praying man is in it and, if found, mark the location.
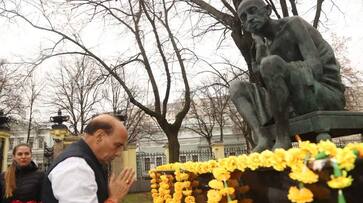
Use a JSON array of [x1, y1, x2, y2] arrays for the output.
[[0, 144, 44, 203]]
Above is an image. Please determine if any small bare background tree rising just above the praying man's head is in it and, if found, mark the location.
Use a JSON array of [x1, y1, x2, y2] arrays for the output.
[[49, 57, 102, 135]]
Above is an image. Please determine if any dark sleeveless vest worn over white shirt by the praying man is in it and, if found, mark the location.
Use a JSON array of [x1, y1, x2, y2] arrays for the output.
[[42, 139, 108, 203]]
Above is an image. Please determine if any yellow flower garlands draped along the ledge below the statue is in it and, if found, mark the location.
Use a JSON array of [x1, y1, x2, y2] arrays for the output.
[[149, 141, 363, 203]]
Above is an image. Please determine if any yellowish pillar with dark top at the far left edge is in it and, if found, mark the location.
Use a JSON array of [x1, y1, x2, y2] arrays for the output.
[[0, 110, 10, 171]]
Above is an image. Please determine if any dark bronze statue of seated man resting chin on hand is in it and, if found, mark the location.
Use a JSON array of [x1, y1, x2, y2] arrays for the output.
[[230, 0, 345, 152]]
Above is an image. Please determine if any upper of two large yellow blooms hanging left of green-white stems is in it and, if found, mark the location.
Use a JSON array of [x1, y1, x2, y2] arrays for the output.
[[289, 164, 319, 184]]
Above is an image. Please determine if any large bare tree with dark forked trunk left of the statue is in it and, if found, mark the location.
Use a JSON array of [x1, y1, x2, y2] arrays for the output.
[[0, 0, 195, 162]]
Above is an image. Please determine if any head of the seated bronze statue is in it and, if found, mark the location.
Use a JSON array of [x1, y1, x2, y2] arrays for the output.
[[237, 0, 271, 33]]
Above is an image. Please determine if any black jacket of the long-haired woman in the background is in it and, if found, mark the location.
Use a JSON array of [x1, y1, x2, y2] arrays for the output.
[[0, 162, 44, 203]]
